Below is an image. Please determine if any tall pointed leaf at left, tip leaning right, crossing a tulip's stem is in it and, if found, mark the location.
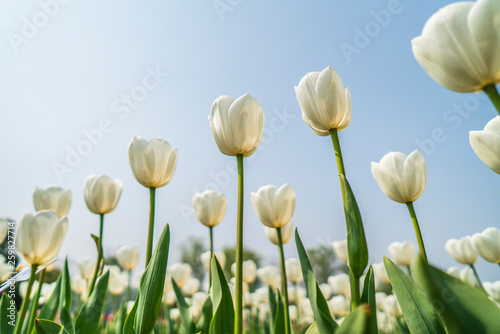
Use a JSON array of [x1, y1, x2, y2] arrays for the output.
[[135, 224, 170, 334]]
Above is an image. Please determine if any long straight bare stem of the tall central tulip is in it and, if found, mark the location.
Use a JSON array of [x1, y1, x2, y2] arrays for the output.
[[234, 154, 243, 334]]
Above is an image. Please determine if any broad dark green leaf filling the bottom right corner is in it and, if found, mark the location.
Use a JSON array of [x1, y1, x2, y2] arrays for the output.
[[412, 255, 500, 334]]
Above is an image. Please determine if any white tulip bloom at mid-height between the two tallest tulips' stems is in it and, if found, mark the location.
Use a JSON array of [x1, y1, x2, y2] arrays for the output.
[[252, 183, 295, 228]]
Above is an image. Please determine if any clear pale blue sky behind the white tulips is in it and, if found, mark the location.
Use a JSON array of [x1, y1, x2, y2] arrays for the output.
[[0, 0, 500, 280]]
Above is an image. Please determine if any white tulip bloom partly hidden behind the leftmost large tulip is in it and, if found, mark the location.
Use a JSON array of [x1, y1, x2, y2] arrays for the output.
[[33, 186, 71, 218]]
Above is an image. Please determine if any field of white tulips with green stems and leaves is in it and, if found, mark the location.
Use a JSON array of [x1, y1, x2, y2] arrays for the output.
[[0, 0, 500, 334]]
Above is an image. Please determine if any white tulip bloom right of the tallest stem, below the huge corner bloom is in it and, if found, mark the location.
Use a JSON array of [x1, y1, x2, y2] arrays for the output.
[[372, 150, 426, 203]]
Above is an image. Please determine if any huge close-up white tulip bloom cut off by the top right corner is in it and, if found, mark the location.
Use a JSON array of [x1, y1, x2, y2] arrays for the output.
[[412, 0, 500, 92]]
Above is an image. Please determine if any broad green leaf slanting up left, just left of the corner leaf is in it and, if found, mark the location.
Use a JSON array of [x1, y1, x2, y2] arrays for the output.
[[384, 256, 446, 334]]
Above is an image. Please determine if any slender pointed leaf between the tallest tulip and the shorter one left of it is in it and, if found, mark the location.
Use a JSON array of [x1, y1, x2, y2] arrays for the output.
[[295, 229, 339, 334]]
